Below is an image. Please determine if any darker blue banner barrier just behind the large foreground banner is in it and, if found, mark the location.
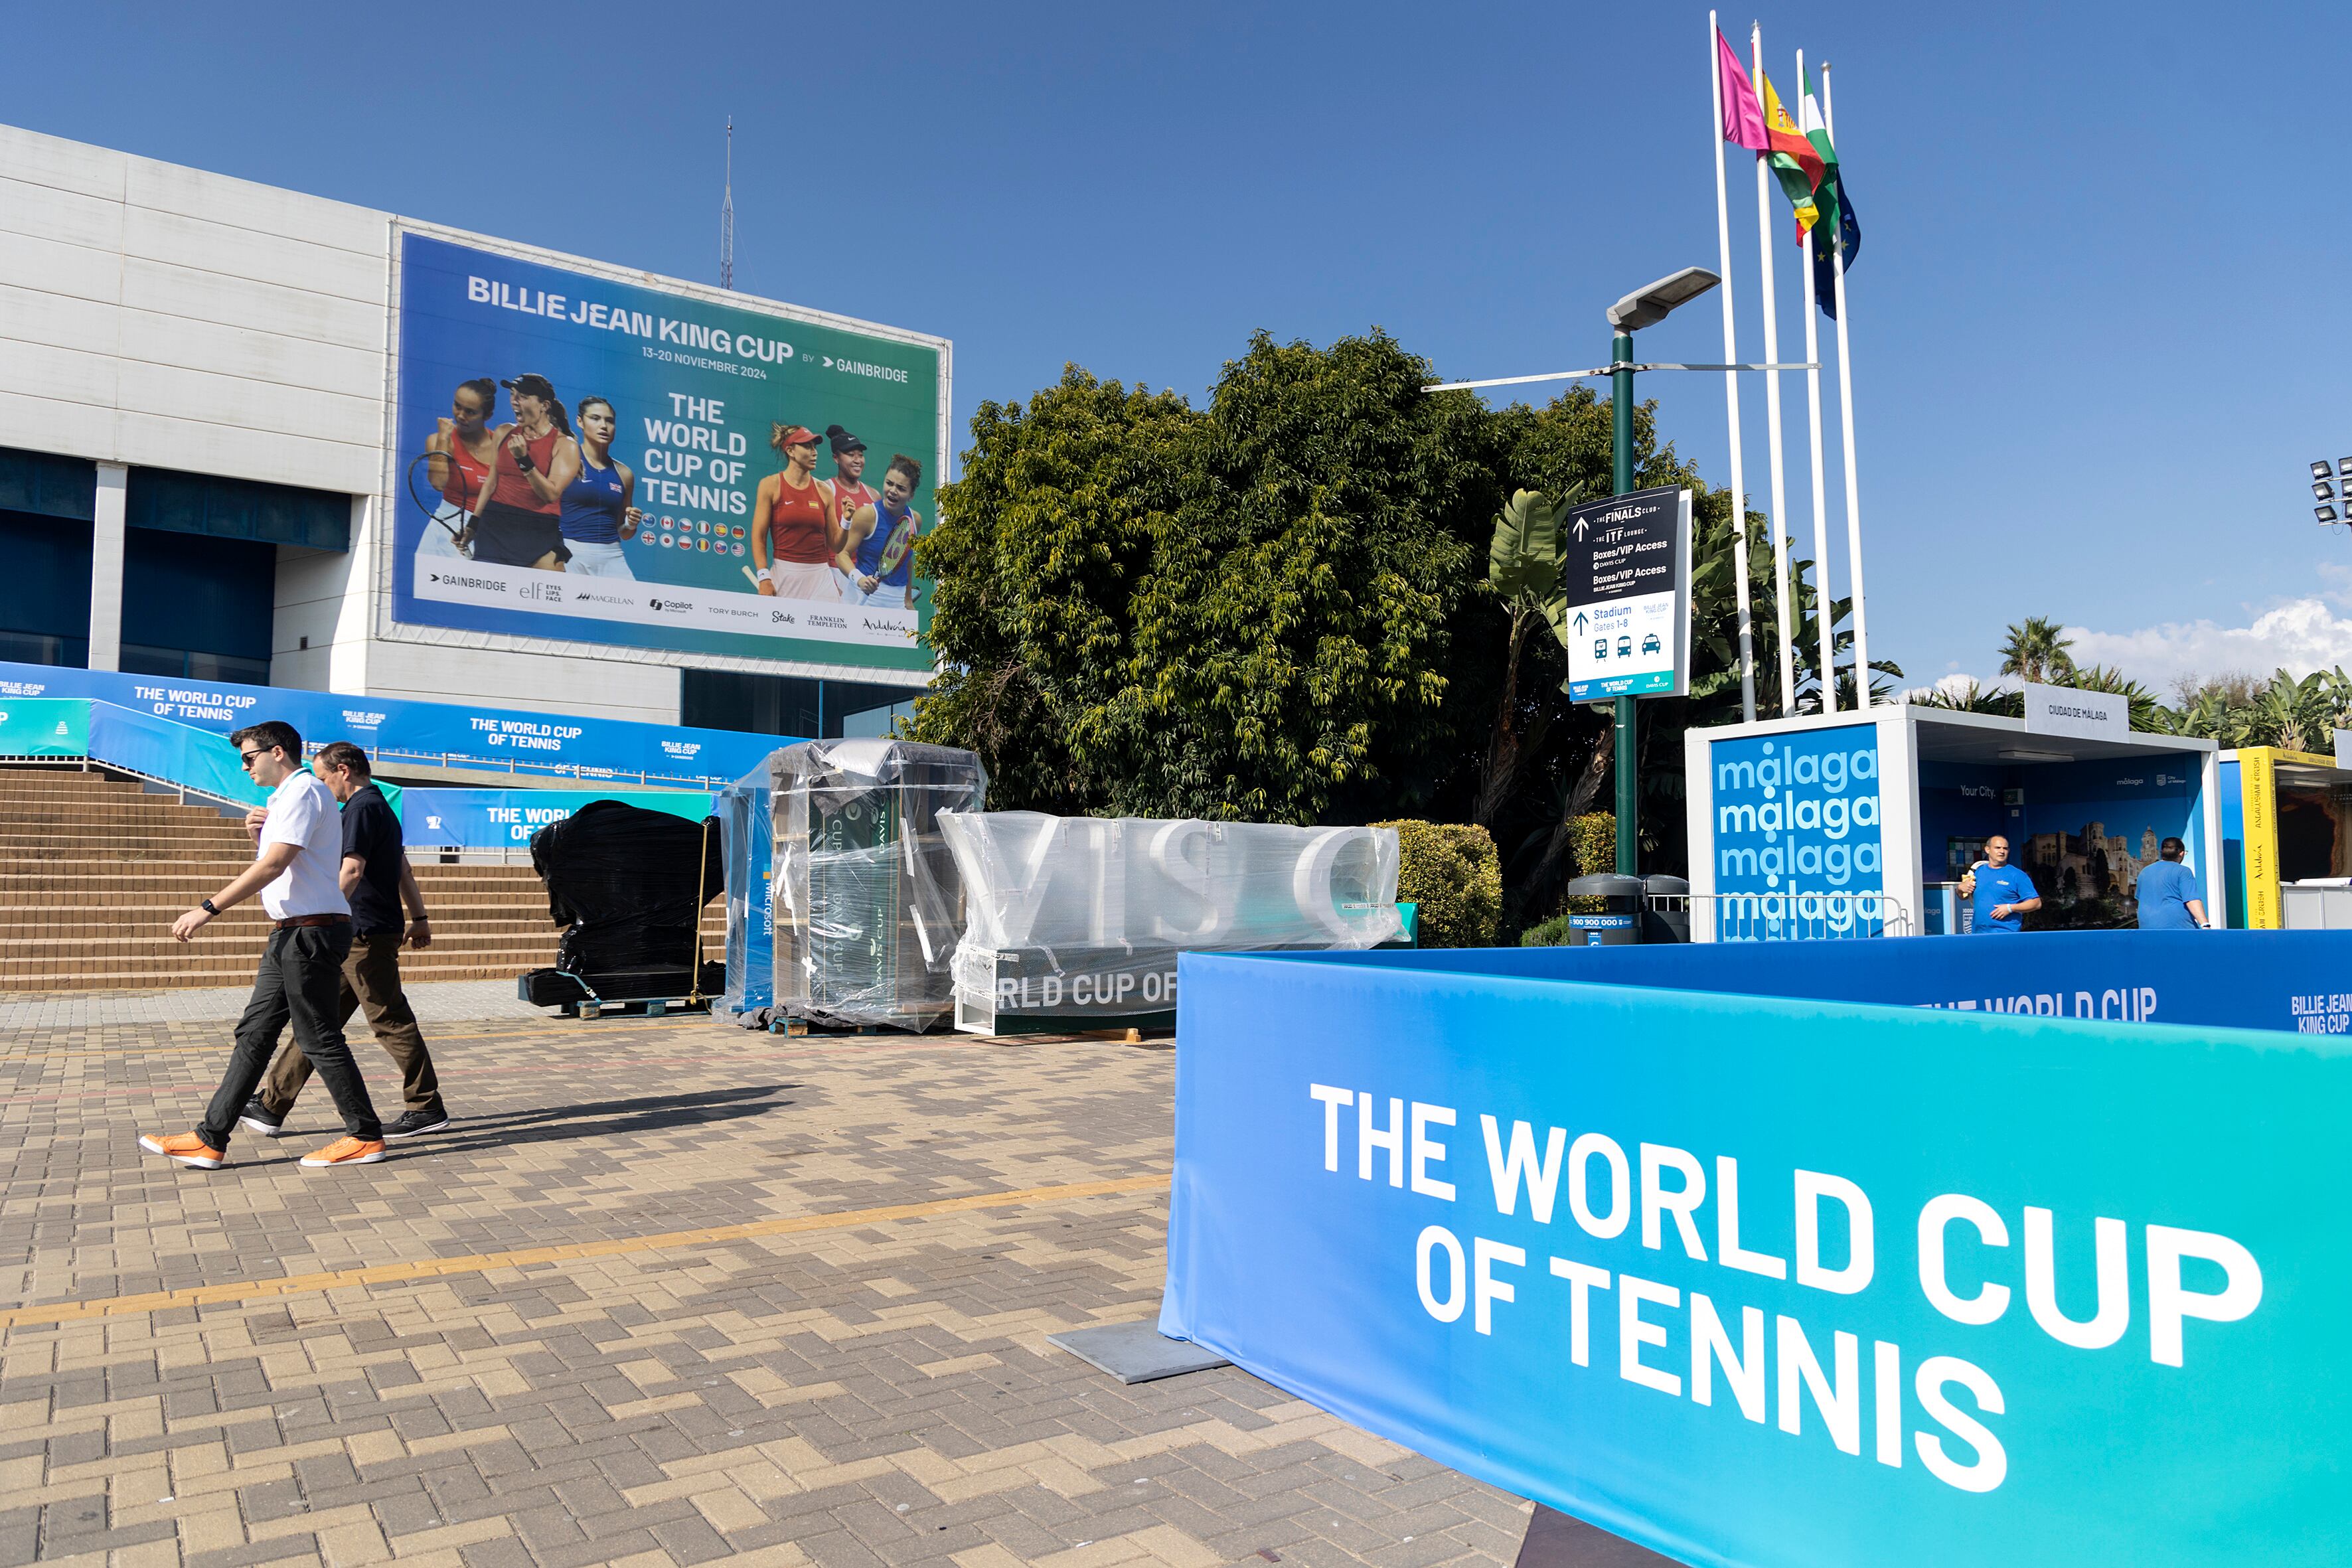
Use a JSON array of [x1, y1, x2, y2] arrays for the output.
[[1329, 931, 2352, 1034]]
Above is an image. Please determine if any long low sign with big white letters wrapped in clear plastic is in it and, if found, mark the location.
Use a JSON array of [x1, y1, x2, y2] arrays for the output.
[[941, 811, 1404, 1034]]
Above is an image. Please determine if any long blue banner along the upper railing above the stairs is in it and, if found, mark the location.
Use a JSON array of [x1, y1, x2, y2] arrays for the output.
[[0, 663, 793, 787]]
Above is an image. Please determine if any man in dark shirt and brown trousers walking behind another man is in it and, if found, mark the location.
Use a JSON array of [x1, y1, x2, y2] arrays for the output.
[[238, 740, 449, 1142]]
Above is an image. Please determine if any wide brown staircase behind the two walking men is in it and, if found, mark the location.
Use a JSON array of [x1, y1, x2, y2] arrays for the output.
[[0, 766, 727, 992]]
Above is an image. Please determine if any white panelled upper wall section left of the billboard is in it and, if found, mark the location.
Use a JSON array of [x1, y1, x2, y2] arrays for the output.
[[0, 127, 390, 494]]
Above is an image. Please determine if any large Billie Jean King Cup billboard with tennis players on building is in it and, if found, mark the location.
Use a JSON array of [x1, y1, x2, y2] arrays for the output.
[[393, 230, 945, 672]]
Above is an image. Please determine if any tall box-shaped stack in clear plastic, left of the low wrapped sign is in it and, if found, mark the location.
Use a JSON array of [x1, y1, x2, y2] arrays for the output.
[[769, 738, 988, 1030]]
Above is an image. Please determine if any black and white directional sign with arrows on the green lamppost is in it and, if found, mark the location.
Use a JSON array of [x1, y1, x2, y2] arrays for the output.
[[1559, 489, 1691, 703]]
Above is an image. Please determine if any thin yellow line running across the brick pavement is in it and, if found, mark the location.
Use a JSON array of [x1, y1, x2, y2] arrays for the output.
[[0, 1173, 1169, 1328]]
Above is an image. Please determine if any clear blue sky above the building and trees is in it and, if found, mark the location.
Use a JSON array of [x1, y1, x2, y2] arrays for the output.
[[0, 3, 2352, 679]]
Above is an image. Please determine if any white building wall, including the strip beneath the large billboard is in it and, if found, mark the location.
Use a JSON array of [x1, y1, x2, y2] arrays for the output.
[[0, 125, 945, 724]]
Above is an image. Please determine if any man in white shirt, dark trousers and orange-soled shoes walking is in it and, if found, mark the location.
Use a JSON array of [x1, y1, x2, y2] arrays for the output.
[[139, 720, 384, 1171]]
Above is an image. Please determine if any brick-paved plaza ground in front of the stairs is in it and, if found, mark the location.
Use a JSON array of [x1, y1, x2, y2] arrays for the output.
[[0, 999, 1529, 1568]]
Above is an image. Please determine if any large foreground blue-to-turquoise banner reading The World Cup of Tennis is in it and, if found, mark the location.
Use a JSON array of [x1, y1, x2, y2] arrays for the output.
[[1162, 938, 2352, 1568]]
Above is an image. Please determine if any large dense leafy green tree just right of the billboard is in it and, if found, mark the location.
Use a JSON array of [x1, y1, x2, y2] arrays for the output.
[[913, 331, 1494, 823]]
